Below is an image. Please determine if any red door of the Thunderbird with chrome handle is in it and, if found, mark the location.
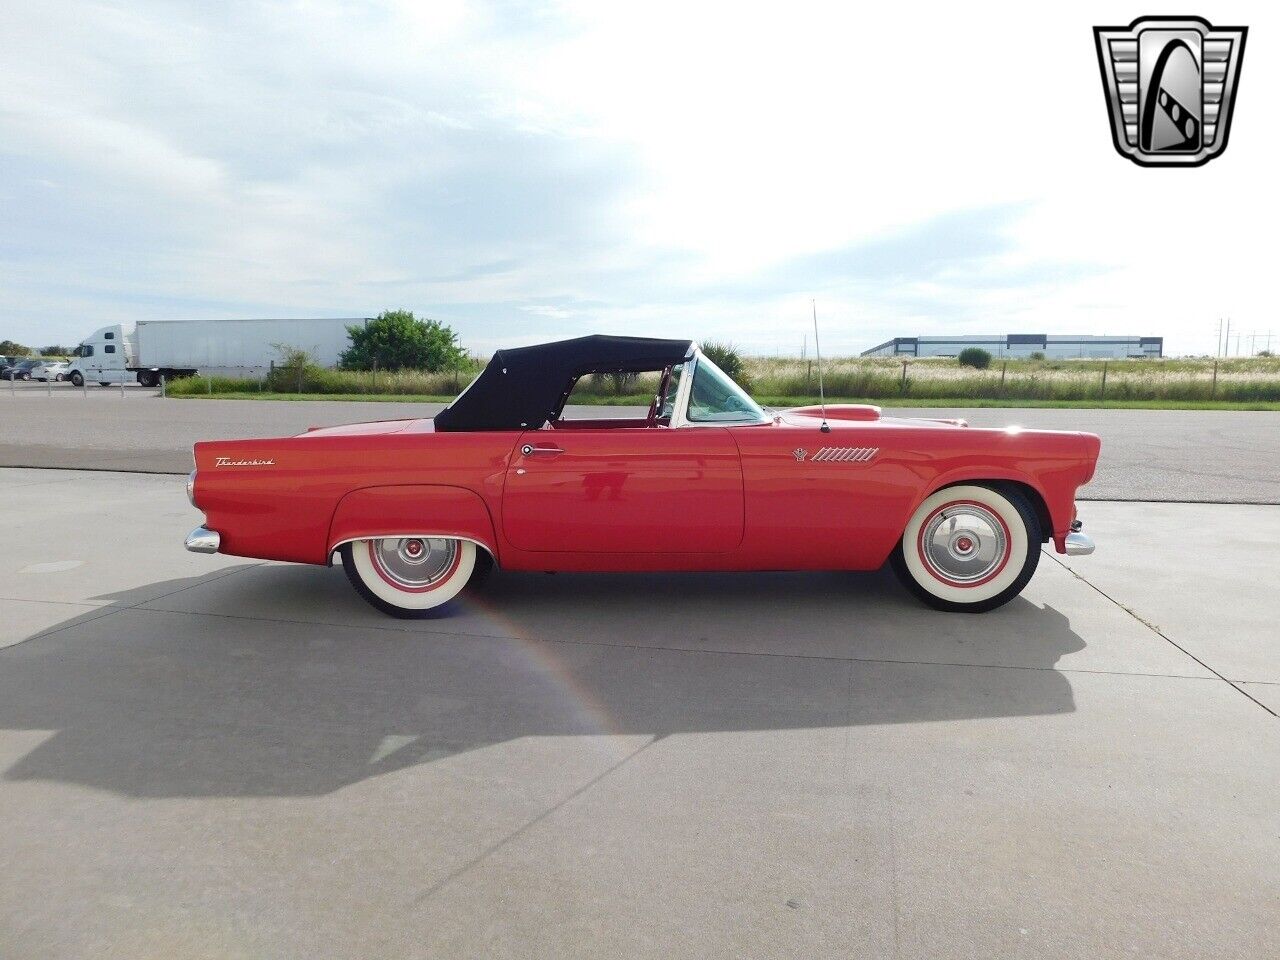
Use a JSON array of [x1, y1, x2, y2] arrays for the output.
[[502, 426, 744, 553]]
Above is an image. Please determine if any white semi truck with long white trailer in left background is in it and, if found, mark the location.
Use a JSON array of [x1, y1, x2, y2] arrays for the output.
[[67, 317, 367, 387]]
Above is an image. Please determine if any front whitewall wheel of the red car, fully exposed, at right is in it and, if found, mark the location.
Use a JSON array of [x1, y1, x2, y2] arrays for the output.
[[893, 484, 1041, 613]]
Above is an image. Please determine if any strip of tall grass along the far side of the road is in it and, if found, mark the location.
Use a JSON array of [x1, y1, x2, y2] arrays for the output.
[[169, 357, 1280, 410]]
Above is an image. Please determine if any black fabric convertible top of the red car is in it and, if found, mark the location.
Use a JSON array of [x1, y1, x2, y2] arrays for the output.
[[435, 335, 694, 430]]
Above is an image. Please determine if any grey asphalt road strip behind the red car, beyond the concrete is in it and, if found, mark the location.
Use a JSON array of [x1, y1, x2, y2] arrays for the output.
[[0, 384, 1280, 503]]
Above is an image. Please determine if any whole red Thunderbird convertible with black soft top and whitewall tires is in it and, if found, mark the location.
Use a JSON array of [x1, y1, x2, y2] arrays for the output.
[[187, 337, 1100, 617]]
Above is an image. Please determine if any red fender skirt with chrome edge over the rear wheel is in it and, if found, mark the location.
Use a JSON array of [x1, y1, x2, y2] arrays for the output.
[[325, 484, 498, 562]]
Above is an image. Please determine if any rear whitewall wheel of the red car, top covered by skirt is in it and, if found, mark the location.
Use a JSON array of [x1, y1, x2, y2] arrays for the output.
[[340, 536, 492, 620]]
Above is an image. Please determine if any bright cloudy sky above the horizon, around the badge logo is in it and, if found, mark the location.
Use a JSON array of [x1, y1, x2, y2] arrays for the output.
[[0, 0, 1280, 356]]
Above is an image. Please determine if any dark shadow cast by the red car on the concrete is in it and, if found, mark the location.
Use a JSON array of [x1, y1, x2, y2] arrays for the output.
[[0, 566, 1084, 797]]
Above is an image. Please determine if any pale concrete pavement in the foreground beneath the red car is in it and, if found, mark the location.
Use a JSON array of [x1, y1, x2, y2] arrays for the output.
[[0, 471, 1280, 960]]
